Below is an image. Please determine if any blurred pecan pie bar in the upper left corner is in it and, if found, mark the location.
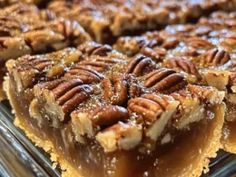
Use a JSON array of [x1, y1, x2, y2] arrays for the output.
[[0, 3, 90, 99]]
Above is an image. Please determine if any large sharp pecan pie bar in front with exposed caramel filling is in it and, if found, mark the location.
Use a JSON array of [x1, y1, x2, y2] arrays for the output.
[[4, 42, 225, 177]]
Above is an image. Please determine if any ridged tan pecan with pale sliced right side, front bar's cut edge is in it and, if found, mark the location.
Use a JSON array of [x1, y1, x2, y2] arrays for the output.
[[128, 94, 178, 141]]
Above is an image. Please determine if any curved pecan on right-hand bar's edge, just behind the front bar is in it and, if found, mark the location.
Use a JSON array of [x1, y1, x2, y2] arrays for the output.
[[165, 57, 201, 79]]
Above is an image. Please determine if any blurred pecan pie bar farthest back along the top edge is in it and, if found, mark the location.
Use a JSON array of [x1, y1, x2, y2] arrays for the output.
[[48, 0, 236, 43]]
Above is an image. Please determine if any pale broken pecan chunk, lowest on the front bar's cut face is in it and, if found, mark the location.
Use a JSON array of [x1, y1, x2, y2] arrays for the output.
[[96, 122, 142, 152]]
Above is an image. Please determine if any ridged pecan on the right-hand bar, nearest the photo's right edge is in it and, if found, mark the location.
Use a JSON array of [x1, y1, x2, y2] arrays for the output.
[[204, 48, 231, 66]]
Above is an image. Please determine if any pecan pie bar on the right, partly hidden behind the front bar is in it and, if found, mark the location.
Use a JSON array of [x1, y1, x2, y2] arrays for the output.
[[114, 12, 236, 153]]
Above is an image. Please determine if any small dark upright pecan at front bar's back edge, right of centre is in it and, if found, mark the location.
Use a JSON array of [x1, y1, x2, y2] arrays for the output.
[[126, 55, 156, 76]]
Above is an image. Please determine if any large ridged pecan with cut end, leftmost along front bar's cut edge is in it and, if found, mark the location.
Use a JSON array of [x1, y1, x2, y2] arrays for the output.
[[34, 78, 93, 126]]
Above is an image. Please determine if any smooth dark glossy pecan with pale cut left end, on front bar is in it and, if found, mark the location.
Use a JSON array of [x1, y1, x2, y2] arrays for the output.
[[71, 105, 129, 137]]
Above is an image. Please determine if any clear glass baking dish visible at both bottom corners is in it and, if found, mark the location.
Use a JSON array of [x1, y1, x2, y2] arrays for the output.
[[0, 101, 236, 177]]
